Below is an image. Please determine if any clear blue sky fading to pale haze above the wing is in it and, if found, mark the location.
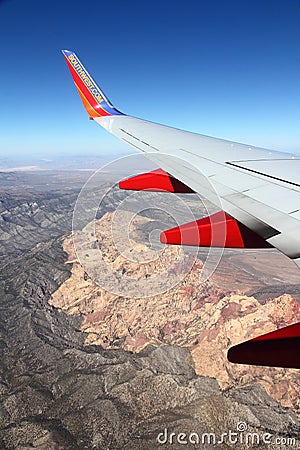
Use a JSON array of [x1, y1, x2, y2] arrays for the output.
[[0, 0, 300, 161]]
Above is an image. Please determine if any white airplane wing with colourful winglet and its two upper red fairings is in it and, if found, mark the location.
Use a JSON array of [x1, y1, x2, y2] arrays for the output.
[[63, 50, 300, 366]]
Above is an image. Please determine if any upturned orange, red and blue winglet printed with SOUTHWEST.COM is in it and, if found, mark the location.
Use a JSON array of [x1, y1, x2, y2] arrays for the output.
[[62, 50, 123, 119]]
